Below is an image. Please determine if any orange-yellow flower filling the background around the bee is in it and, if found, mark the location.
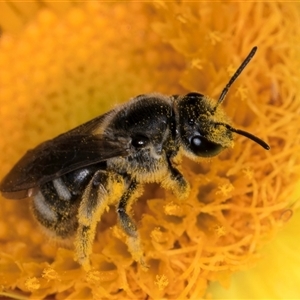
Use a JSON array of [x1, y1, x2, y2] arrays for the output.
[[0, 1, 300, 299]]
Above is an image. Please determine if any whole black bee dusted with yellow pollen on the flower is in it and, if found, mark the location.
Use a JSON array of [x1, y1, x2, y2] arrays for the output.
[[0, 47, 270, 269]]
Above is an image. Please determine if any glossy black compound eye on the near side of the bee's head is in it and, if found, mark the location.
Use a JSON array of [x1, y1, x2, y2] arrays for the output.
[[190, 135, 223, 157]]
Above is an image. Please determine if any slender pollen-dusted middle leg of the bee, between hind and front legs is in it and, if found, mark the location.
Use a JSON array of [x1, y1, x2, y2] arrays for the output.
[[117, 181, 148, 268]]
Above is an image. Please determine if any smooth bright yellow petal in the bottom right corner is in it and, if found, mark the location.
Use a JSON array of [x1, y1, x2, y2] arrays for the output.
[[207, 210, 300, 299]]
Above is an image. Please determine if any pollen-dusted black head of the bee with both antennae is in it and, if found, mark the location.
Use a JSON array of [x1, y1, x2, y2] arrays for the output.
[[175, 47, 270, 158]]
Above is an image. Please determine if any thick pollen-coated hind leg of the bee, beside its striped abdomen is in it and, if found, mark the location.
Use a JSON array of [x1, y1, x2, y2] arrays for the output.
[[75, 171, 110, 270]]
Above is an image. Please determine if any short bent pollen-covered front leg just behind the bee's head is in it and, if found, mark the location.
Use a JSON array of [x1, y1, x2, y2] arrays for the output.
[[161, 158, 190, 199]]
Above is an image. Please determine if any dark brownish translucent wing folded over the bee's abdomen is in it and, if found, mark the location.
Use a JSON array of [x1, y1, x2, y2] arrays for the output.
[[0, 132, 129, 199]]
